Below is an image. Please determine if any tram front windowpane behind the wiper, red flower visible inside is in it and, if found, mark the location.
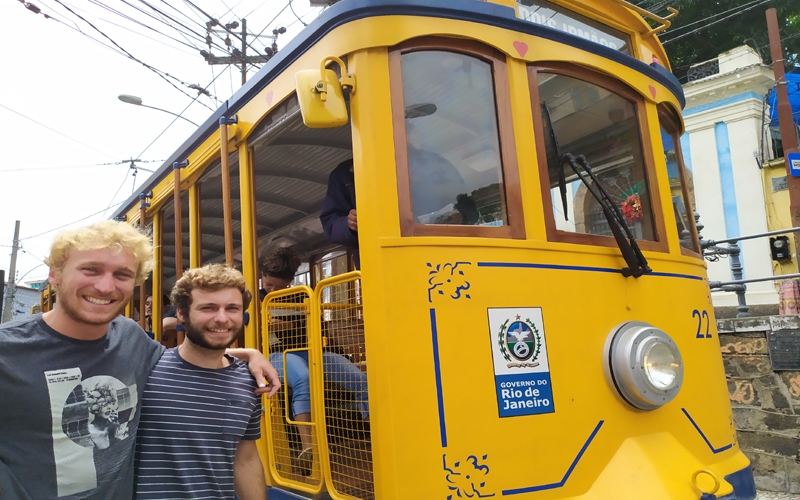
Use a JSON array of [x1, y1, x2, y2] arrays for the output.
[[534, 71, 658, 241]]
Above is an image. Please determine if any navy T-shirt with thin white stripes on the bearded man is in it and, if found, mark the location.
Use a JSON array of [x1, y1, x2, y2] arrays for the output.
[[134, 348, 262, 500]]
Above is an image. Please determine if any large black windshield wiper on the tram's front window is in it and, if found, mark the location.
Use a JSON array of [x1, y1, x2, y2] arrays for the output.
[[559, 153, 653, 278]]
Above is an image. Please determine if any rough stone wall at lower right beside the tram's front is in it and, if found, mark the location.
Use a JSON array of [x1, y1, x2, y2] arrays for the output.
[[717, 316, 800, 493]]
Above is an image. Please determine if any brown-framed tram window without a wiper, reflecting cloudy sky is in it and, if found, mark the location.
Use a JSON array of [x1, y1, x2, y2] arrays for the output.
[[390, 41, 522, 237]]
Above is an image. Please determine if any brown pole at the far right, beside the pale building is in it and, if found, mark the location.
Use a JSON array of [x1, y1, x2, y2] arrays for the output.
[[766, 8, 800, 253]]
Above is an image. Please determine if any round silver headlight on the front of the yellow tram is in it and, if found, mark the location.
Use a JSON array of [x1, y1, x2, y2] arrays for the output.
[[604, 321, 683, 410]]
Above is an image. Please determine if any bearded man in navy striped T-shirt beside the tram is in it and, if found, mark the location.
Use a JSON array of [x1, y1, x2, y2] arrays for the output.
[[134, 264, 266, 500]]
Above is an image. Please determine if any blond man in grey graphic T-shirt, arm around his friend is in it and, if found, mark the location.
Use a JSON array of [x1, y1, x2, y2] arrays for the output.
[[0, 221, 280, 500]]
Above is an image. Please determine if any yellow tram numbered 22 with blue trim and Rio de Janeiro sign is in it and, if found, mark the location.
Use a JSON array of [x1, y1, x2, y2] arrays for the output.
[[104, 0, 755, 500]]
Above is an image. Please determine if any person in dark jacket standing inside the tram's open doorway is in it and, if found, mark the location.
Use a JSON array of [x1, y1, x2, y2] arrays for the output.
[[319, 158, 361, 269]]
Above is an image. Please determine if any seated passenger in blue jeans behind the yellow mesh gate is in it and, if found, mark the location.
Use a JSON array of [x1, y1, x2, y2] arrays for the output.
[[260, 248, 369, 473]]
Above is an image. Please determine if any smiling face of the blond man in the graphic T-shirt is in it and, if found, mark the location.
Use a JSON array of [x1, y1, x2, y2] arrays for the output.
[[49, 248, 139, 337]]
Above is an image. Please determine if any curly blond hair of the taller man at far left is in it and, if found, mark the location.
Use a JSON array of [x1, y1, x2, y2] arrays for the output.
[[44, 220, 155, 285]]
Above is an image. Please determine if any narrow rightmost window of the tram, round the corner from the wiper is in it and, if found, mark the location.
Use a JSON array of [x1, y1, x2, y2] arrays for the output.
[[658, 105, 700, 253]]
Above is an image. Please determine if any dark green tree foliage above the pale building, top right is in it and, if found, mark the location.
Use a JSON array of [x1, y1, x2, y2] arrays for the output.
[[638, 0, 800, 82]]
